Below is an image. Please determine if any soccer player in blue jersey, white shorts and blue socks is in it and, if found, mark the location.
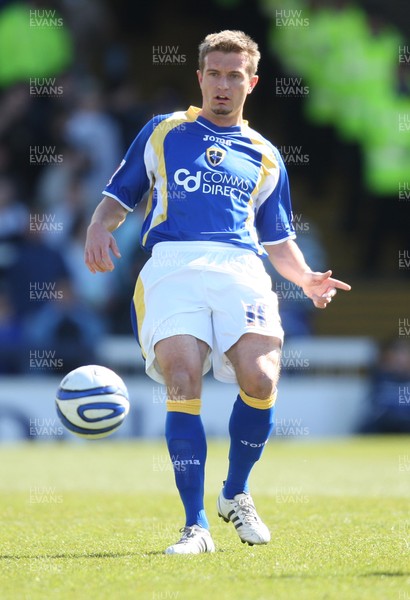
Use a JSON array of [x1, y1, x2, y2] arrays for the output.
[[85, 30, 350, 554]]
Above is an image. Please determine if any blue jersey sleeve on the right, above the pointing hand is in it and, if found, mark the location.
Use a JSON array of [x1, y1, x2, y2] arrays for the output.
[[255, 149, 296, 245]]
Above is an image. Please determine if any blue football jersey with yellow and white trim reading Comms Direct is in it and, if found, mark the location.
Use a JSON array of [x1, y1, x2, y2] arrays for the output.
[[103, 106, 296, 255]]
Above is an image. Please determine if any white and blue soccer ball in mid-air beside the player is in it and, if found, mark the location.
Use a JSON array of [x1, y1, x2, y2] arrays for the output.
[[56, 365, 130, 440]]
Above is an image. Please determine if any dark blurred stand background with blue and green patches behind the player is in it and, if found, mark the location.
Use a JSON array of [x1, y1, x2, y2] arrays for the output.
[[0, 0, 410, 380]]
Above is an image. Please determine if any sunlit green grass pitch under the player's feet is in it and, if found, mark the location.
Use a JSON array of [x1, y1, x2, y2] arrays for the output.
[[0, 437, 410, 600]]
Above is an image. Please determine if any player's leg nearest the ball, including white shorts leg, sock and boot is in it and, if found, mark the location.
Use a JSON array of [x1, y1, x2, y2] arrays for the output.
[[131, 247, 214, 554]]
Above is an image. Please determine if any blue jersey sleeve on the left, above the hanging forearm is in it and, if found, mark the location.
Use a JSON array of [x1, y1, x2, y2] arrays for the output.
[[103, 118, 158, 211]]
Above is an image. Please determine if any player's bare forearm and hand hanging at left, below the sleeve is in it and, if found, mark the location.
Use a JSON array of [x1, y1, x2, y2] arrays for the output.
[[84, 196, 128, 273]]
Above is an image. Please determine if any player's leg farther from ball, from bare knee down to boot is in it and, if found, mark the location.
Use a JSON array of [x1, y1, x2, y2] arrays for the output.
[[218, 333, 281, 545]]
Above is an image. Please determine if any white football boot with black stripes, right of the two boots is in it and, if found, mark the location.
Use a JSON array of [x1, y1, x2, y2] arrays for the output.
[[217, 490, 270, 546]]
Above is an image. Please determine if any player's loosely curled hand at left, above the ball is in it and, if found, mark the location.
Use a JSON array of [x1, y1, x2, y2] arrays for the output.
[[84, 223, 121, 273]]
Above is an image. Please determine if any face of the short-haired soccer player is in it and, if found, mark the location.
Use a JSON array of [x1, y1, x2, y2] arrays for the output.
[[197, 51, 258, 127]]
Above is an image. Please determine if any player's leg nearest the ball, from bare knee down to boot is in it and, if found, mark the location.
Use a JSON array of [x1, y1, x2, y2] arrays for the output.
[[155, 335, 214, 554]]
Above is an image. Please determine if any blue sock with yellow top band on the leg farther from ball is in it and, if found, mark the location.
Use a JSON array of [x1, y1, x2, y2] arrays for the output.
[[223, 390, 276, 498]]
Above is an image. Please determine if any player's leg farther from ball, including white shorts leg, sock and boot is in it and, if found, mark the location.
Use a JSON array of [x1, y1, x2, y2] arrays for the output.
[[211, 247, 283, 544]]
